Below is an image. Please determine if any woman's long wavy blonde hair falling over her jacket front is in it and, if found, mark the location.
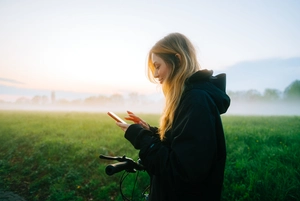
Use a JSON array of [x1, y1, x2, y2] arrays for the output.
[[148, 33, 200, 140]]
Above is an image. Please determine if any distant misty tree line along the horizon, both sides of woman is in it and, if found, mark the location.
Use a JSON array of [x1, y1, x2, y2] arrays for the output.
[[0, 80, 300, 105]]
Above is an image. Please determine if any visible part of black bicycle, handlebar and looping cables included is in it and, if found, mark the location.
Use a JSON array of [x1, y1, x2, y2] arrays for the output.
[[99, 154, 149, 201]]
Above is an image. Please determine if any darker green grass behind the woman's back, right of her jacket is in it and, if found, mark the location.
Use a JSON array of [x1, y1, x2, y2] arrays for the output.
[[223, 116, 300, 200]]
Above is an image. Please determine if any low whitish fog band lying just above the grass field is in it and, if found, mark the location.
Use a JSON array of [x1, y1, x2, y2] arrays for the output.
[[0, 100, 300, 116]]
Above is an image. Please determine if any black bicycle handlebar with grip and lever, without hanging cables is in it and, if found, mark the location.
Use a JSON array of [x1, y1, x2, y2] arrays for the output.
[[99, 155, 145, 176]]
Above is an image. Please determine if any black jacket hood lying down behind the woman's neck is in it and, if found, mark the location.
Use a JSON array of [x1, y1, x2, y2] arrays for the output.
[[185, 70, 230, 114]]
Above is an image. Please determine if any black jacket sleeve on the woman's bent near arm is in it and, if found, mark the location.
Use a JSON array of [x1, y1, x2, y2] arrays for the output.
[[125, 92, 216, 182]]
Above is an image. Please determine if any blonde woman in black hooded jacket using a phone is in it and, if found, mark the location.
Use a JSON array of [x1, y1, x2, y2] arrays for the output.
[[117, 33, 230, 201]]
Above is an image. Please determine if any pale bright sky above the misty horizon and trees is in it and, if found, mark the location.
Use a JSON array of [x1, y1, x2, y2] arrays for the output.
[[0, 0, 300, 99]]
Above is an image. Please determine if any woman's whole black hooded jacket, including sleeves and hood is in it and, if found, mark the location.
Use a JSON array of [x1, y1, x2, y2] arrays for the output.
[[125, 70, 230, 201]]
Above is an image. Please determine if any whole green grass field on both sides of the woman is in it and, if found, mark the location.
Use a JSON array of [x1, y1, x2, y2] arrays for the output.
[[0, 111, 300, 201]]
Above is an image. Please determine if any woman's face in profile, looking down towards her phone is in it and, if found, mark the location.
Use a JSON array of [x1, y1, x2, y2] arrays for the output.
[[151, 53, 171, 84]]
